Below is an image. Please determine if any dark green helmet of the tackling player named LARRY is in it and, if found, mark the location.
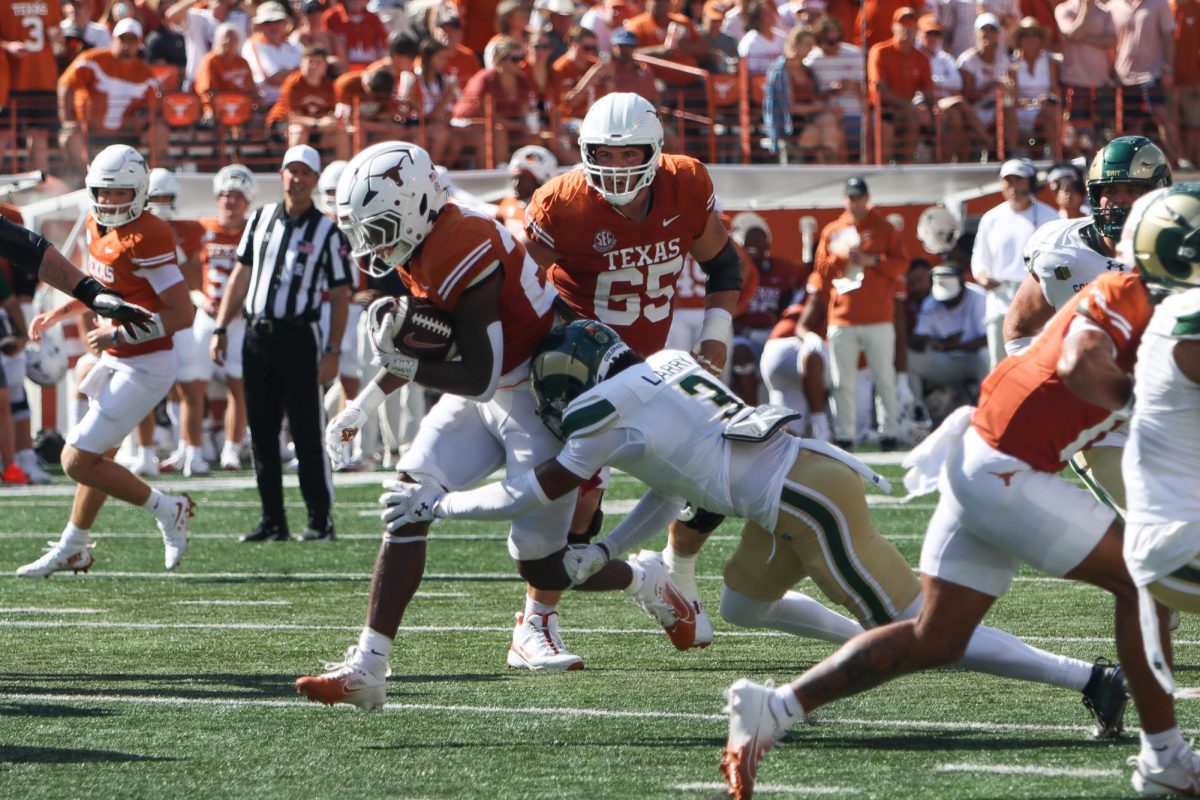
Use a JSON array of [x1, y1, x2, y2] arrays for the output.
[[529, 319, 631, 439]]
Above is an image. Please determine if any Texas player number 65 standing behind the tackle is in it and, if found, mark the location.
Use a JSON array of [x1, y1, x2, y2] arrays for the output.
[[520, 92, 742, 669]]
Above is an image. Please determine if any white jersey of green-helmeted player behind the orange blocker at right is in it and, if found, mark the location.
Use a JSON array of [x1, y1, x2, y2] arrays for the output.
[[1025, 217, 1130, 308]]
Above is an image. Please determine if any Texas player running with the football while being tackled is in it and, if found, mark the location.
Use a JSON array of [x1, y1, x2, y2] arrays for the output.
[[296, 143, 695, 709]]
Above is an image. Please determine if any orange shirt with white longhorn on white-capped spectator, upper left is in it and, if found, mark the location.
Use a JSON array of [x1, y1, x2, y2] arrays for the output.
[[59, 48, 158, 131]]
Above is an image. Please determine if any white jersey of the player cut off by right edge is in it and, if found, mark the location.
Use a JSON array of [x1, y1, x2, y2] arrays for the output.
[[1121, 289, 1200, 523]]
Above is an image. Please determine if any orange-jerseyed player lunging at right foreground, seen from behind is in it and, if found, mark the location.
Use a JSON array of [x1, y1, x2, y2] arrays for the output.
[[721, 199, 1200, 798]]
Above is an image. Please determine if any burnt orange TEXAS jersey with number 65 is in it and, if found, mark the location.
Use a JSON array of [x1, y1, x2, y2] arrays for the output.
[[526, 155, 716, 356]]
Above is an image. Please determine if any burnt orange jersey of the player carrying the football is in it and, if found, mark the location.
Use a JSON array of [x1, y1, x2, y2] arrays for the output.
[[397, 203, 554, 375]]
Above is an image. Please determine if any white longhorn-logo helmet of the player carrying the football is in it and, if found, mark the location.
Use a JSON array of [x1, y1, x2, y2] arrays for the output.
[[337, 142, 446, 277]]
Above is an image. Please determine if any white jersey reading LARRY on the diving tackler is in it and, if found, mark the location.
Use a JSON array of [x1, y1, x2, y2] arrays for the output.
[[558, 350, 800, 530]]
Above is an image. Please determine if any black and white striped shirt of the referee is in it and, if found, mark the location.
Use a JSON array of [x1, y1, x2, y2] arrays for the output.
[[238, 203, 353, 319]]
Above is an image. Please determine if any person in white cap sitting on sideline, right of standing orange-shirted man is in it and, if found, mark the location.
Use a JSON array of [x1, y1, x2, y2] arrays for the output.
[[908, 264, 988, 419]]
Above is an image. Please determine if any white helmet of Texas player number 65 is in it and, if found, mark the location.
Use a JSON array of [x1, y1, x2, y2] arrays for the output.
[[580, 92, 662, 205]]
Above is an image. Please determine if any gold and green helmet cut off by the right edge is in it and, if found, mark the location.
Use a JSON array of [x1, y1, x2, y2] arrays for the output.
[[1122, 184, 1200, 291]]
